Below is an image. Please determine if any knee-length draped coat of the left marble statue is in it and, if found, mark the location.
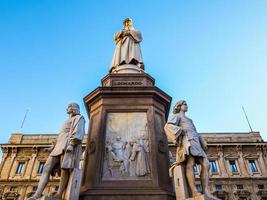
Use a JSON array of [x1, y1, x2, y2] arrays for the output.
[[49, 115, 85, 173]]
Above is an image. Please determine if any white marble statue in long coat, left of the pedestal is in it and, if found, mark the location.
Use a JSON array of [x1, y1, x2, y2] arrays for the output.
[[28, 103, 85, 200]]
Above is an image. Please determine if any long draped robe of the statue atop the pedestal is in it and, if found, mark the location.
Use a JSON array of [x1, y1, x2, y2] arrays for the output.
[[110, 29, 144, 71]]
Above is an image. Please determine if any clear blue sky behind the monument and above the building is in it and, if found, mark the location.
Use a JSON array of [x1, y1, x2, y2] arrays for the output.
[[0, 0, 267, 148]]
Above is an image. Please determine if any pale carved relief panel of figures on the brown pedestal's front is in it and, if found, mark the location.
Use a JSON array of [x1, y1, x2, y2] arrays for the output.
[[102, 112, 150, 180]]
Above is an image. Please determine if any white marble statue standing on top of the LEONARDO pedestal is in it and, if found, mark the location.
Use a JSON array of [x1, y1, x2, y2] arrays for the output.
[[109, 18, 144, 72]]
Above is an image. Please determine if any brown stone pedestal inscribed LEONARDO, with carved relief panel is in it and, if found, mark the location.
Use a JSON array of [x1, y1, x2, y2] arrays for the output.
[[80, 73, 175, 200]]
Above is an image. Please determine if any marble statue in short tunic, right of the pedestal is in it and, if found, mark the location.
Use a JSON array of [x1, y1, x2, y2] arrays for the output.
[[164, 100, 218, 200]]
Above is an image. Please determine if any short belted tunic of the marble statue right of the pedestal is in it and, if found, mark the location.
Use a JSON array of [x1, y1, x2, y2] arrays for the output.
[[165, 114, 207, 163]]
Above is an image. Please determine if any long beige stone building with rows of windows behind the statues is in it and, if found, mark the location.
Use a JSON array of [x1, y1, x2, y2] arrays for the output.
[[0, 132, 267, 200]]
